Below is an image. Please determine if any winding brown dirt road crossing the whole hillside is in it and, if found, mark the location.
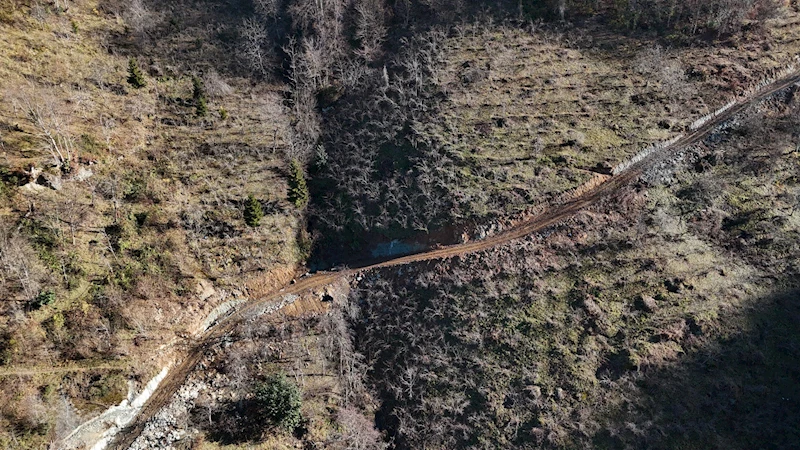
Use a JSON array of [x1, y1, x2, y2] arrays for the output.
[[109, 67, 800, 449]]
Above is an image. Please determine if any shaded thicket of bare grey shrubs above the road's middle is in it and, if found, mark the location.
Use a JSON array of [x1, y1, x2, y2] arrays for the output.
[[315, 35, 457, 251]]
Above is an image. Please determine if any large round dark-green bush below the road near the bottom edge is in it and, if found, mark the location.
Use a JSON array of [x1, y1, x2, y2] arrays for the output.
[[255, 374, 302, 431]]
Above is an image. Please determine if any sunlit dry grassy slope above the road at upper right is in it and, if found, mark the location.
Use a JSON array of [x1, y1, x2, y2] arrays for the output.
[[428, 13, 800, 216]]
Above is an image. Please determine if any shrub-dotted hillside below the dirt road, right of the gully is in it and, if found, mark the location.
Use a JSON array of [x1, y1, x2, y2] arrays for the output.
[[351, 98, 800, 449]]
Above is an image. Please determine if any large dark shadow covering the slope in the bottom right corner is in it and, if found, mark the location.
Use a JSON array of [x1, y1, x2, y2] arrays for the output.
[[592, 287, 800, 449]]
